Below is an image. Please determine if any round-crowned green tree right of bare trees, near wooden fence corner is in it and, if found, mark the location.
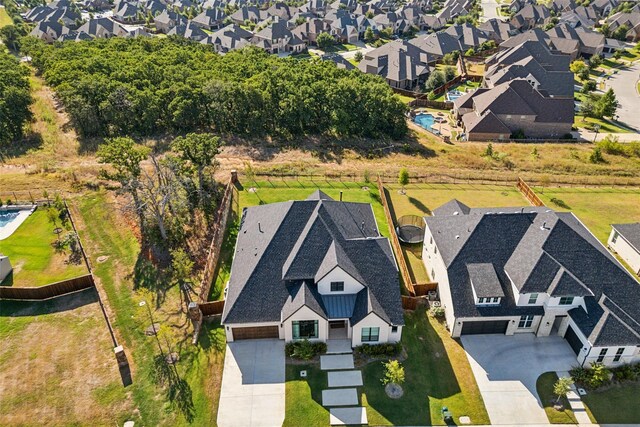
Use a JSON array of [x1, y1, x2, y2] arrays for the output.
[[171, 133, 221, 208]]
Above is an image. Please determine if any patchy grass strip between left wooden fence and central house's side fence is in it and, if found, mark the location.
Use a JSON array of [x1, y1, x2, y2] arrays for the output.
[[74, 192, 226, 426]]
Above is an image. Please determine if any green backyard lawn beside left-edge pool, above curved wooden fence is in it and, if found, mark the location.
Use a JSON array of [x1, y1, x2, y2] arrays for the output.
[[0, 208, 87, 287]]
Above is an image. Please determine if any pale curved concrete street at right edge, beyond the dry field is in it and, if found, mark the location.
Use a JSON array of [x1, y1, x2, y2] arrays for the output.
[[605, 62, 640, 131]]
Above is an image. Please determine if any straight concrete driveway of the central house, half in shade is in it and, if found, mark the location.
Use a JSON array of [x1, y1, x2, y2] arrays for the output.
[[218, 340, 284, 427]]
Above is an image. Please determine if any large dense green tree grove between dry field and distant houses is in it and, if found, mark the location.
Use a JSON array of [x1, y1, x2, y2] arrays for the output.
[[22, 37, 407, 138]]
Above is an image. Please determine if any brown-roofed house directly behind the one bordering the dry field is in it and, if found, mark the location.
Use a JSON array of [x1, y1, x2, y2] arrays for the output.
[[483, 41, 574, 99]]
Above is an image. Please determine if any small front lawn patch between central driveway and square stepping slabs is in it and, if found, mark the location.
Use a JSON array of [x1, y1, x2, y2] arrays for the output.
[[282, 363, 329, 427]]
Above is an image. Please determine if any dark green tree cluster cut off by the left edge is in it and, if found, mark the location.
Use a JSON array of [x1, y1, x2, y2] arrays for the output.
[[0, 51, 33, 145]]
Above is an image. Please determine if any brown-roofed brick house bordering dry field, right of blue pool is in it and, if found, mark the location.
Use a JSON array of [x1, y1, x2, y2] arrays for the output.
[[453, 78, 574, 141]]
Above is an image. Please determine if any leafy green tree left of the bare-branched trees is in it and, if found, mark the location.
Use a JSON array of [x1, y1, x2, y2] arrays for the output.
[[97, 138, 150, 229]]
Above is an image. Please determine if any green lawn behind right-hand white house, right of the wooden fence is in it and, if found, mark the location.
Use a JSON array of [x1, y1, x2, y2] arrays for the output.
[[535, 187, 640, 245]]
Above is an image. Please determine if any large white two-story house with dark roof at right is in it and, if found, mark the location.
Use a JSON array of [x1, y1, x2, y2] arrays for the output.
[[422, 200, 640, 366]]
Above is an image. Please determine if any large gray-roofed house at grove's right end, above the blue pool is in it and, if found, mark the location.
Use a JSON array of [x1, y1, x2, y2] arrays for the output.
[[358, 40, 430, 89]]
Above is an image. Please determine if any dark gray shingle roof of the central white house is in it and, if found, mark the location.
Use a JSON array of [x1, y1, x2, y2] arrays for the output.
[[222, 192, 403, 325]]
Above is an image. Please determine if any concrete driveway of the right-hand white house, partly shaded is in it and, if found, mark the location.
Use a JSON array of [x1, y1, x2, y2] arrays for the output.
[[461, 334, 578, 425]]
